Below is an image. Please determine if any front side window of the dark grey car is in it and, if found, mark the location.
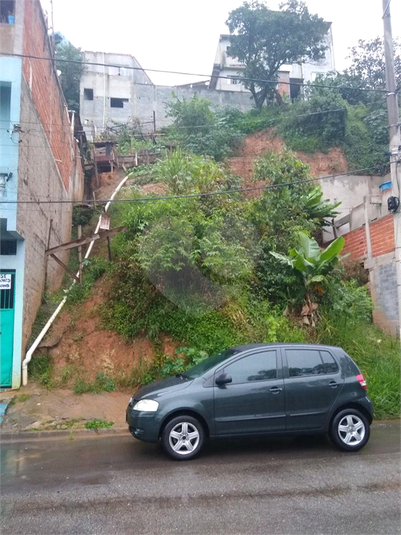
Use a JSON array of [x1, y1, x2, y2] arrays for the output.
[[224, 351, 277, 384]]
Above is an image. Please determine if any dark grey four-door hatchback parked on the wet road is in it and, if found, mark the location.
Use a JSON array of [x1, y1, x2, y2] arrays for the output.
[[126, 344, 373, 459]]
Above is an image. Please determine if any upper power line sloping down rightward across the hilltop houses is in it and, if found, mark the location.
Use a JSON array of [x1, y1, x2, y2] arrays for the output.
[[0, 53, 387, 94]]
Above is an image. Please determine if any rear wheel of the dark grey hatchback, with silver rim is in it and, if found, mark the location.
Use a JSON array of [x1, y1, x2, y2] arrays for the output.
[[330, 408, 370, 451]]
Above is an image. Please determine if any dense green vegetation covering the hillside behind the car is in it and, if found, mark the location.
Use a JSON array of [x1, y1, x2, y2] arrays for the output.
[[36, 33, 400, 418]]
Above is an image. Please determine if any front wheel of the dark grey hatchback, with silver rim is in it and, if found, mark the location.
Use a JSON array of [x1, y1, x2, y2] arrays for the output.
[[161, 415, 205, 461]]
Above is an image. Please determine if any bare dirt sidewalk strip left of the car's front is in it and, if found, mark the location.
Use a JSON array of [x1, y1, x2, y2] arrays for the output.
[[0, 382, 130, 436]]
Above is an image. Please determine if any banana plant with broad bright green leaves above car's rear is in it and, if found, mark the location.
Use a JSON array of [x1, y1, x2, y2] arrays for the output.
[[270, 232, 345, 326]]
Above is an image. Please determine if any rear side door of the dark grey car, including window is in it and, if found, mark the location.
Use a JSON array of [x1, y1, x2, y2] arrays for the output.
[[284, 348, 344, 431]]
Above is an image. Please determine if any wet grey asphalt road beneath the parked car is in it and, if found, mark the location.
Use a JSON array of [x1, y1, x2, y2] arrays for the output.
[[1, 423, 401, 535]]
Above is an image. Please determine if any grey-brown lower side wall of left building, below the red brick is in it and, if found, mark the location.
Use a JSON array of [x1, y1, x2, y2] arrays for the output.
[[17, 81, 76, 347]]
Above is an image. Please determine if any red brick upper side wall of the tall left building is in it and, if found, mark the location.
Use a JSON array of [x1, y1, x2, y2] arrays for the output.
[[22, 0, 73, 191]]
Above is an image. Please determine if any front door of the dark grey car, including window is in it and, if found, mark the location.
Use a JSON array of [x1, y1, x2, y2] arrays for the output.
[[213, 349, 285, 435]]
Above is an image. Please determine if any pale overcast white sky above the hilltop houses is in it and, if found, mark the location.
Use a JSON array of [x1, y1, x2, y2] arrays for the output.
[[41, 0, 401, 85]]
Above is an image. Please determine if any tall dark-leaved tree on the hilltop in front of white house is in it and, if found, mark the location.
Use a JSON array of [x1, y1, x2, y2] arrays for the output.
[[226, 0, 329, 109]]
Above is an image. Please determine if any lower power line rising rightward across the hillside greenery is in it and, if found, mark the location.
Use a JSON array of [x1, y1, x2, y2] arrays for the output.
[[0, 164, 386, 205]]
